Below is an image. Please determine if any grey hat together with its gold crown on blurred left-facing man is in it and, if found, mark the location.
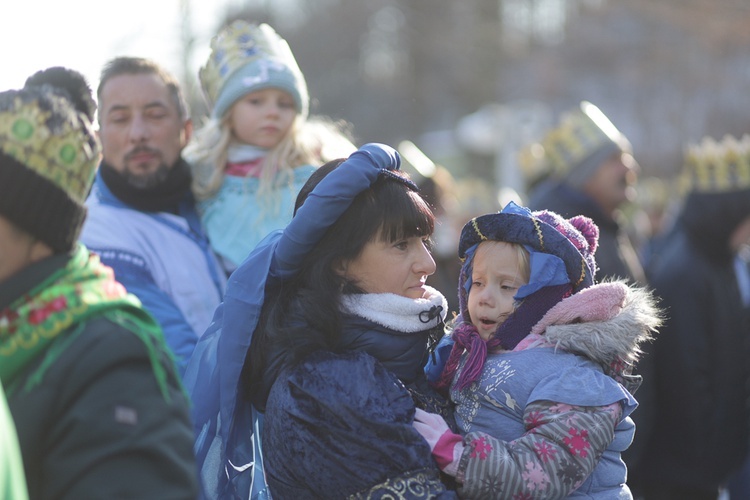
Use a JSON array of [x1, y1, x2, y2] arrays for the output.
[[519, 101, 632, 187]]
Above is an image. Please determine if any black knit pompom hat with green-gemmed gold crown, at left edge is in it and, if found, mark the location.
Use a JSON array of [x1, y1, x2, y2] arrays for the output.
[[0, 67, 101, 253]]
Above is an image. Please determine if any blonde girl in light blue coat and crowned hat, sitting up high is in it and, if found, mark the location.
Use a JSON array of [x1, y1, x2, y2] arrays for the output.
[[185, 20, 354, 273]]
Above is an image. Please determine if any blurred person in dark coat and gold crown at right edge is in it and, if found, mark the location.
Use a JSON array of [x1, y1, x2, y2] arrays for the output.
[[639, 135, 750, 500]]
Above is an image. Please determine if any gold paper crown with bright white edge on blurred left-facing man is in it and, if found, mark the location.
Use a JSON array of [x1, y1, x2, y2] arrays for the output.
[[522, 101, 630, 176]]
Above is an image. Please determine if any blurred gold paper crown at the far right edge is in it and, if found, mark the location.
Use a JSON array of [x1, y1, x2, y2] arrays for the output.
[[680, 134, 750, 192]]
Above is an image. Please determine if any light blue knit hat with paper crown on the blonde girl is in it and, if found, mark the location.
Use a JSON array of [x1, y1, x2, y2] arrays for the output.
[[198, 20, 310, 119]]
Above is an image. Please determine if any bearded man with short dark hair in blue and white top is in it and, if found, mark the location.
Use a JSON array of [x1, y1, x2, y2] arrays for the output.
[[81, 57, 226, 373]]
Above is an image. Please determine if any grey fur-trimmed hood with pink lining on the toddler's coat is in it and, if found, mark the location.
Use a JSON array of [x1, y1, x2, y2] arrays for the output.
[[516, 281, 662, 374]]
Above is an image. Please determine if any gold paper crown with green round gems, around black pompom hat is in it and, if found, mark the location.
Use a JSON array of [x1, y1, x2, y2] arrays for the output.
[[0, 90, 101, 203]]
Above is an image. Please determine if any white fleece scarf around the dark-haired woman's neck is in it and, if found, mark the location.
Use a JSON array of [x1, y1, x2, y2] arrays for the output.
[[341, 286, 448, 333]]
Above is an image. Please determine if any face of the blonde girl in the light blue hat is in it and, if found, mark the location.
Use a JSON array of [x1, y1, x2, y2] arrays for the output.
[[229, 88, 297, 149]]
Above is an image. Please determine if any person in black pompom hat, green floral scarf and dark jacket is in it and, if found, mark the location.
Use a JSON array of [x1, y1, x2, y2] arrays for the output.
[[0, 67, 198, 499]]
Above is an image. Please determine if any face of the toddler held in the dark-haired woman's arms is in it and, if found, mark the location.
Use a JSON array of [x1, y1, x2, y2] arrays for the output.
[[468, 241, 529, 340]]
